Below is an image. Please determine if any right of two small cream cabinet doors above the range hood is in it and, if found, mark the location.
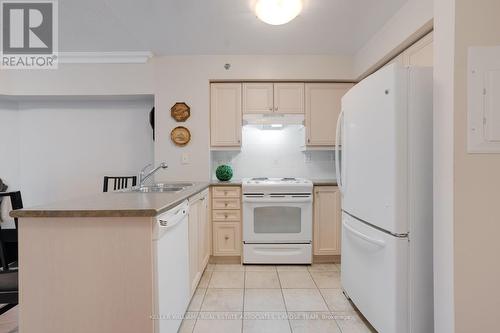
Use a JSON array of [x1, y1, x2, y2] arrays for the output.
[[274, 83, 304, 114]]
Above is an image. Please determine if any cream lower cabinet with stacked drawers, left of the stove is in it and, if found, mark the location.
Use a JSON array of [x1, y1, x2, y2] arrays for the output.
[[211, 186, 242, 256]]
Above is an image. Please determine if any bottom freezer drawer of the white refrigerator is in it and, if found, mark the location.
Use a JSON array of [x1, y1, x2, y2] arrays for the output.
[[341, 213, 409, 333]]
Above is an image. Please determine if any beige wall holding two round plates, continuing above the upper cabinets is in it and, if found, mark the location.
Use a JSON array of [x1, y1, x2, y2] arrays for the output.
[[153, 55, 352, 180]]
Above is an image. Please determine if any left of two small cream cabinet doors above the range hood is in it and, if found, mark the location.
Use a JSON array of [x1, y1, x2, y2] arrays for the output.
[[243, 83, 274, 114]]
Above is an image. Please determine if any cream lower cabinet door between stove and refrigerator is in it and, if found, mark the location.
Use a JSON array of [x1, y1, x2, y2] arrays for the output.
[[313, 186, 342, 255]]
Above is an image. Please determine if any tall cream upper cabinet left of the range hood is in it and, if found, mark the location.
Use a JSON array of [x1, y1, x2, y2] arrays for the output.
[[210, 83, 242, 147]]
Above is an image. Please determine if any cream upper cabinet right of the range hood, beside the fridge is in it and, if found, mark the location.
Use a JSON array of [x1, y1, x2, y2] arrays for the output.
[[305, 83, 353, 146]]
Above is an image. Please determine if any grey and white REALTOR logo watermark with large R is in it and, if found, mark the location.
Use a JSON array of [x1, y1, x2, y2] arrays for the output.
[[0, 0, 58, 69]]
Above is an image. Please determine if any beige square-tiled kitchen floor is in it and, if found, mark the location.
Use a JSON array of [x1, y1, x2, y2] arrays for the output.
[[179, 264, 375, 333]]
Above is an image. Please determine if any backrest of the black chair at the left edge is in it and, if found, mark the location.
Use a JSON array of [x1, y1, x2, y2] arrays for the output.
[[0, 191, 23, 271]]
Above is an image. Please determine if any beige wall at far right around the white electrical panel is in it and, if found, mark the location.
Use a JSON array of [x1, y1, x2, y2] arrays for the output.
[[454, 0, 500, 333]]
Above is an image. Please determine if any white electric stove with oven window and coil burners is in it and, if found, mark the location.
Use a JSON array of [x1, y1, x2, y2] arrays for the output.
[[242, 178, 313, 264]]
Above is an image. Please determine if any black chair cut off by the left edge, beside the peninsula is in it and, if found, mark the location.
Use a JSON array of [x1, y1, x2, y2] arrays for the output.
[[0, 191, 23, 315]]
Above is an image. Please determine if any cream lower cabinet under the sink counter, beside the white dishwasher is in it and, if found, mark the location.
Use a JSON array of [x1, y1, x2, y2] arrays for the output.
[[188, 190, 210, 295]]
